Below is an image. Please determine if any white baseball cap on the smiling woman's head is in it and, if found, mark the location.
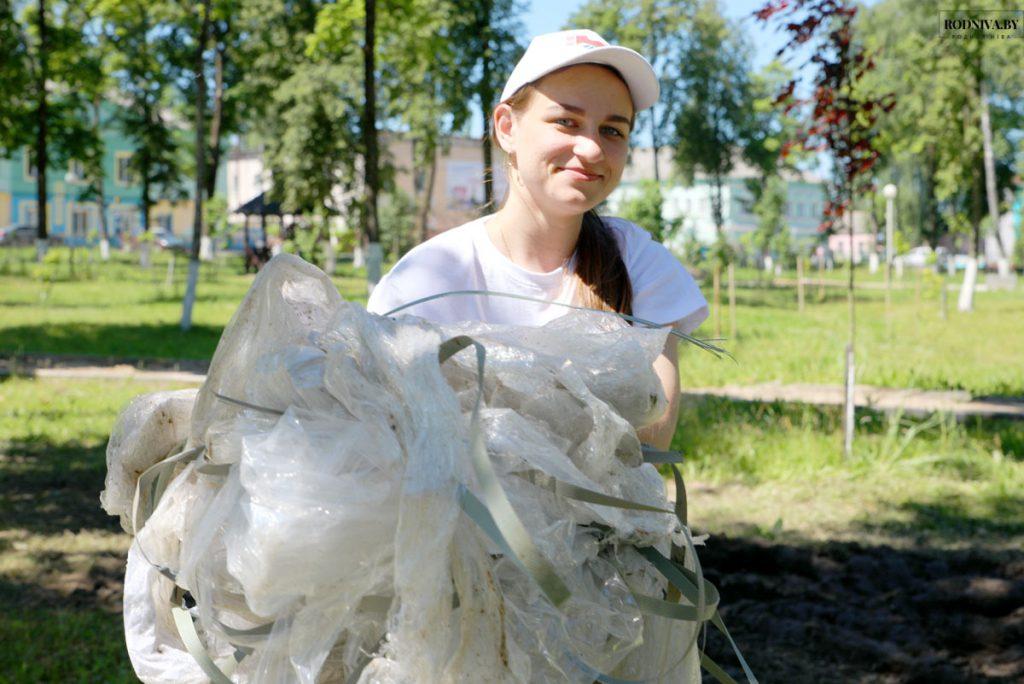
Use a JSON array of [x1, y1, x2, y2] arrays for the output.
[[501, 29, 660, 112]]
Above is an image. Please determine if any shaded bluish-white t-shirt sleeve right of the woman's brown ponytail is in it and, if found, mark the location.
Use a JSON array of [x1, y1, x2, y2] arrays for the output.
[[610, 219, 709, 334]]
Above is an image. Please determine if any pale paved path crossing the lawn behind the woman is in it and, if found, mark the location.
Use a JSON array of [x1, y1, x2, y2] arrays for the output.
[[0, 356, 1024, 419]]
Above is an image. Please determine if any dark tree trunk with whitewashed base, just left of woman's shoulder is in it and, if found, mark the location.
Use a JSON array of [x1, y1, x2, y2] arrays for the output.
[[362, 0, 382, 292]]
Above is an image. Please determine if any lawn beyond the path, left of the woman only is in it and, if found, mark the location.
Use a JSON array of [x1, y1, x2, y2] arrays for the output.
[[0, 249, 366, 359]]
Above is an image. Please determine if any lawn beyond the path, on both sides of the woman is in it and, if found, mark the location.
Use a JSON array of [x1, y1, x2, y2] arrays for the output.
[[0, 245, 1024, 395]]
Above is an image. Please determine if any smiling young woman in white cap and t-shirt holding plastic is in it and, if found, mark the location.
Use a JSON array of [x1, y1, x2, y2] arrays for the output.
[[367, 31, 708, 448]]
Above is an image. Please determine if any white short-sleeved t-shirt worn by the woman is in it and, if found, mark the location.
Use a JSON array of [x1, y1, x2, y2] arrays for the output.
[[367, 214, 708, 333]]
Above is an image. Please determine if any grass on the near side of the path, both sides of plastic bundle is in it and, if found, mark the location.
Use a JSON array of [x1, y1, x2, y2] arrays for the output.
[[0, 378, 1024, 682]]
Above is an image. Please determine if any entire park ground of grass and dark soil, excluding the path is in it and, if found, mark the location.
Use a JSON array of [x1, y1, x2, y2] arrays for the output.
[[0, 251, 1024, 682]]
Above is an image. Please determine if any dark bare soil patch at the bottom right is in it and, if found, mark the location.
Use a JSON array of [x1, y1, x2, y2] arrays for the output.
[[700, 537, 1024, 683]]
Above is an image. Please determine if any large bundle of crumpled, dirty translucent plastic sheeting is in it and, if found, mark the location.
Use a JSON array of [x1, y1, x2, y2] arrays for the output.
[[103, 255, 699, 684]]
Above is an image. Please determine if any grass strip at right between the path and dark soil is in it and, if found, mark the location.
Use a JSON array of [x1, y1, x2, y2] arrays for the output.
[[673, 398, 1024, 551]]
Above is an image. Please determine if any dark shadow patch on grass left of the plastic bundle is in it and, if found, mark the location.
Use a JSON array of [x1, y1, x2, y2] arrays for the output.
[[0, 440, 121, 535]]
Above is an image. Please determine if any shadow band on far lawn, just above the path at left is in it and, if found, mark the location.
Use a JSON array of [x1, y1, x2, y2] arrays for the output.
[[0, 323, 223, 358]]
